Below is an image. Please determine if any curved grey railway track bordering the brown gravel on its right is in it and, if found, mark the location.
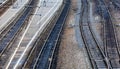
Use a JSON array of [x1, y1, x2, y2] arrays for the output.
[[80, 0, 111, 69]]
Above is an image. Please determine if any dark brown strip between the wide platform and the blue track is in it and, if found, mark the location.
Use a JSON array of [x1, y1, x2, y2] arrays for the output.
[[22, 6, 63, 68]]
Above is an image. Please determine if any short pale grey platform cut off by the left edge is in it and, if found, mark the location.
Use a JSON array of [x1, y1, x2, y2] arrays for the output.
[[0, 0, 29, 32]]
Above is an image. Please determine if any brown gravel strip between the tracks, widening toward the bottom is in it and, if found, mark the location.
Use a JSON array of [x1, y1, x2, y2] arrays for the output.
[[57, 0, 88, 69]]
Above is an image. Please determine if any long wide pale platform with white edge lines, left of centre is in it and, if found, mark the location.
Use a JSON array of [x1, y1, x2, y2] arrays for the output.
[[5, 0, 63, 69]]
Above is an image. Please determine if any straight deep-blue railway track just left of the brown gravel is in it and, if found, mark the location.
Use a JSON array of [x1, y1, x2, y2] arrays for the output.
[[33, 0, 70, 69]]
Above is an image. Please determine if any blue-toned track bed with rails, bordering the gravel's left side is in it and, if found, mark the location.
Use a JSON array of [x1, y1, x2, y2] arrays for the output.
[[32, 0, 69, 69]]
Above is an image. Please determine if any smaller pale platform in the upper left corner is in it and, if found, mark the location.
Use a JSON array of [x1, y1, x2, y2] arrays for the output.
[[0, 0, 29, 31]]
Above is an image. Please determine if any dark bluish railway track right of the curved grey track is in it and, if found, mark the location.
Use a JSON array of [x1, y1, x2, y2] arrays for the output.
[[96, 0, 120, 69]]
